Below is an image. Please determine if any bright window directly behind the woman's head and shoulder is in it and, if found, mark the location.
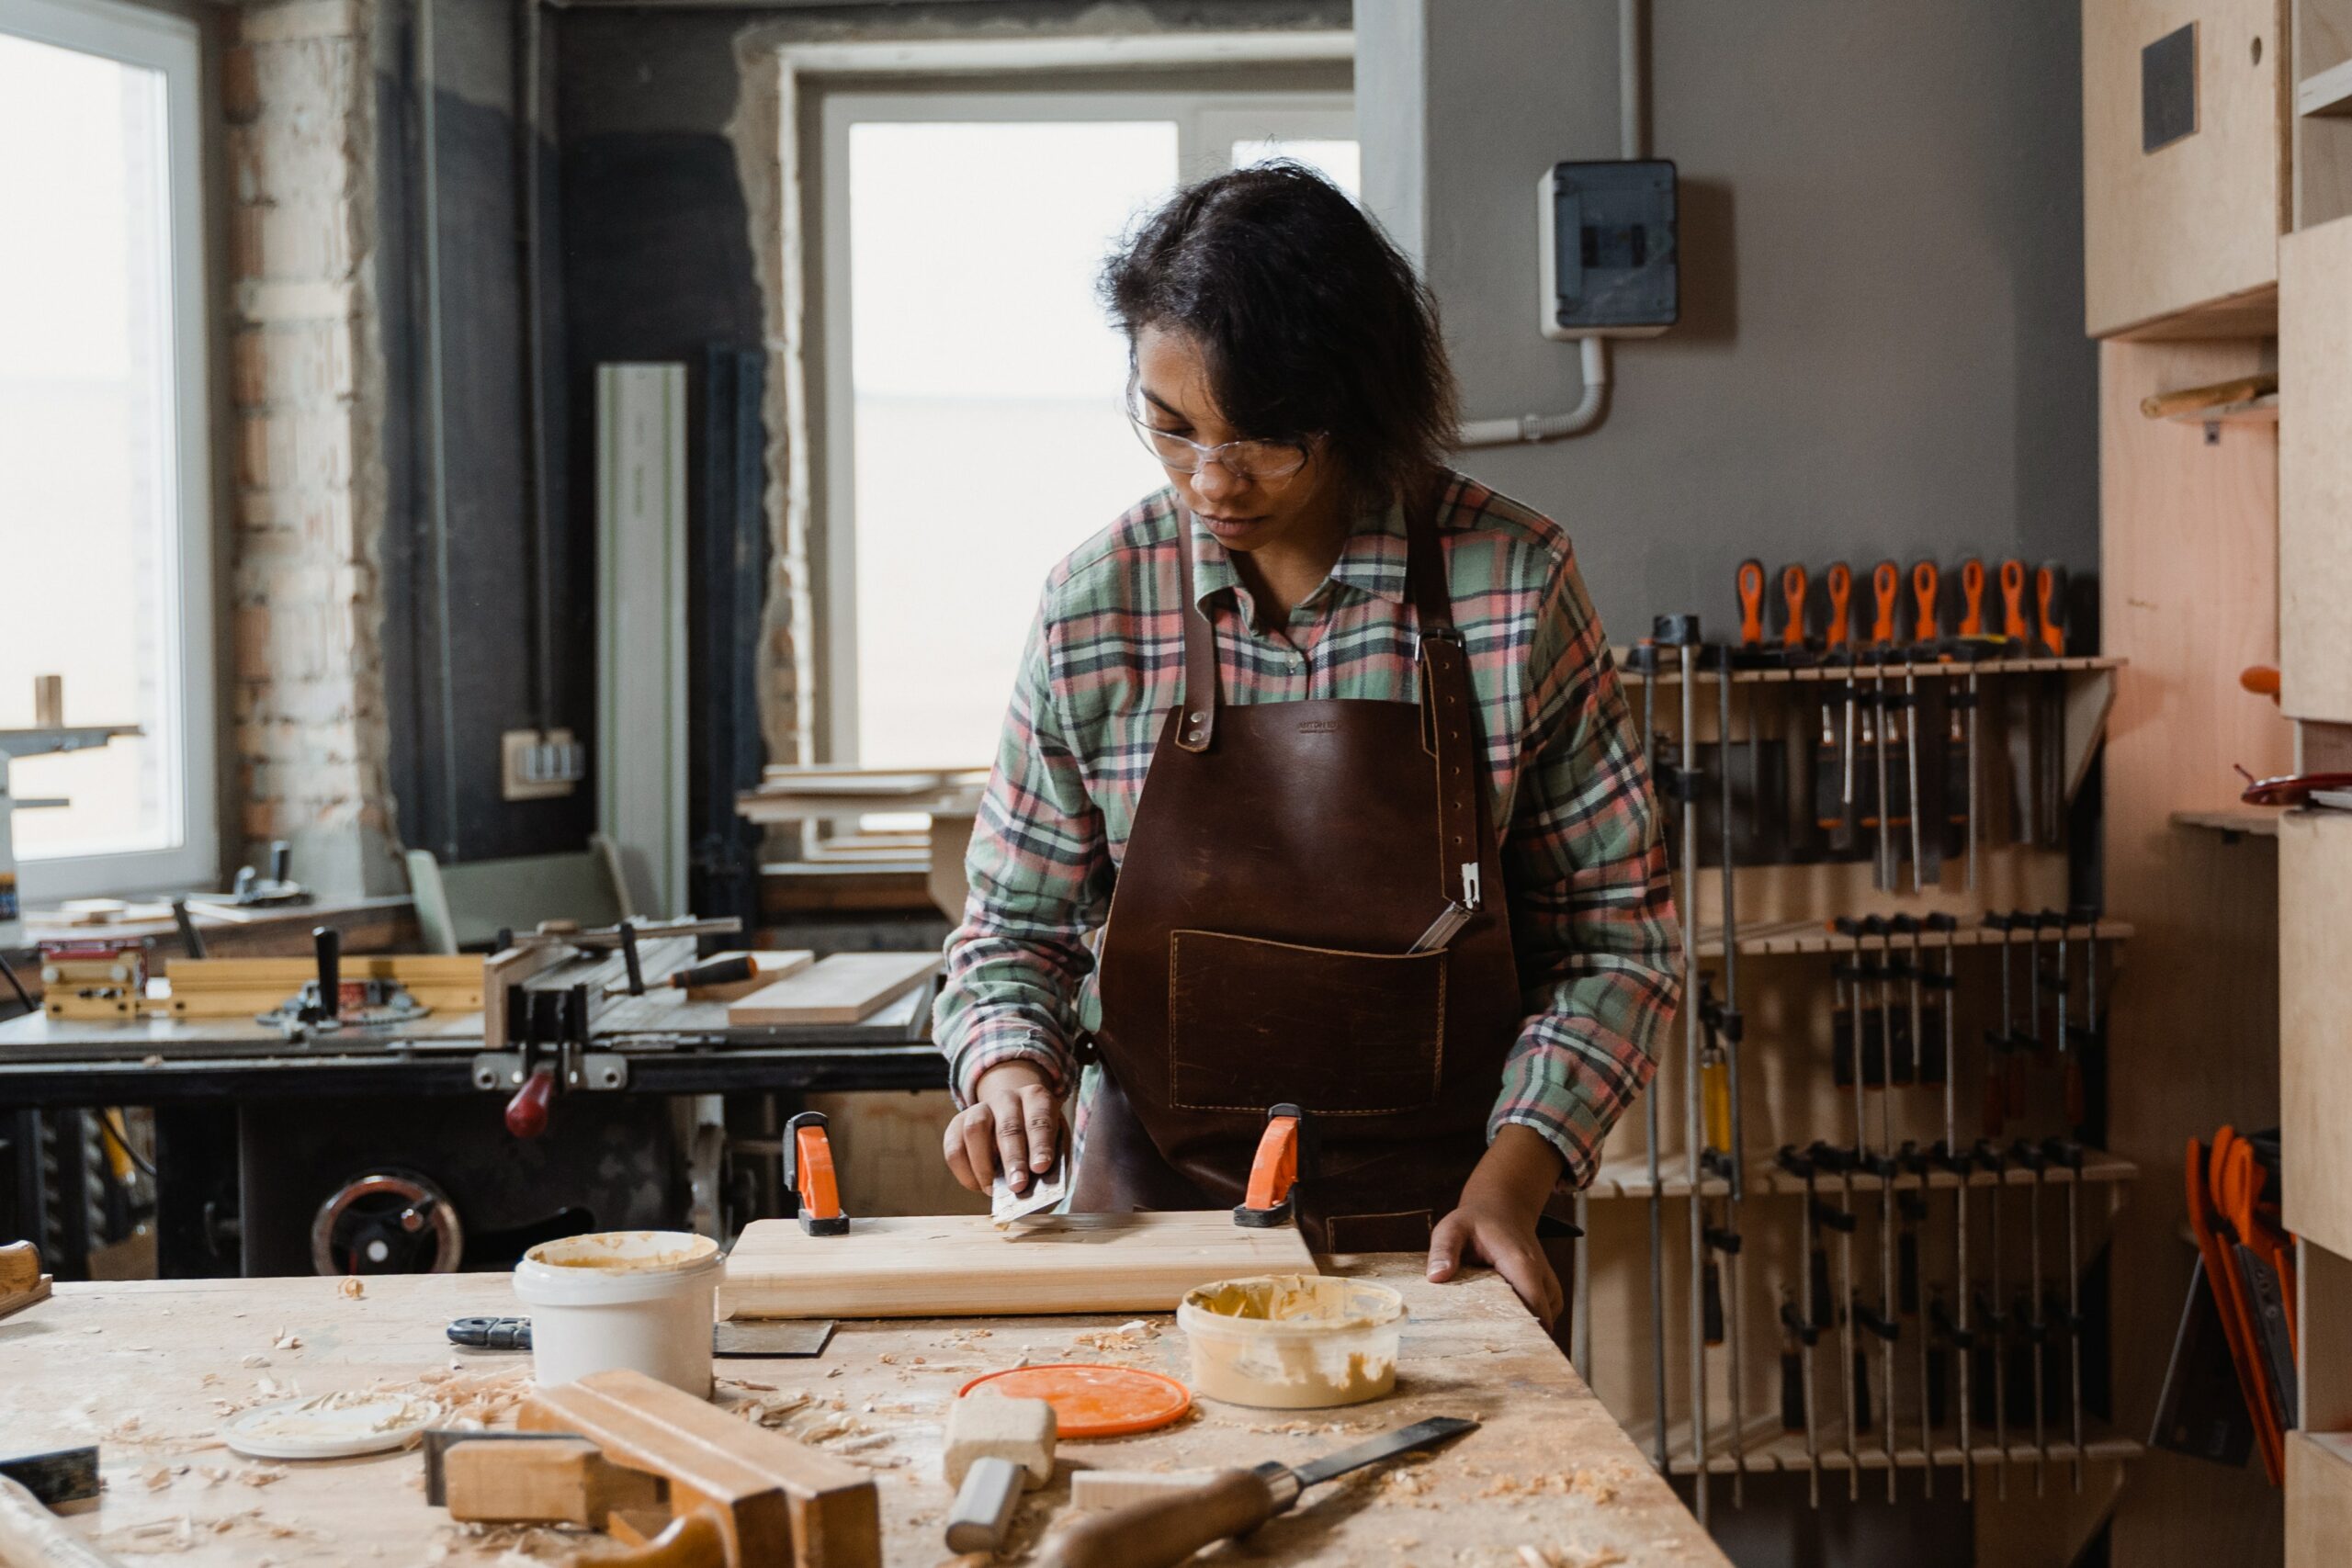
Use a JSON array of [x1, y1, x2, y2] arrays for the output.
[[820, 92, 1357, 769]]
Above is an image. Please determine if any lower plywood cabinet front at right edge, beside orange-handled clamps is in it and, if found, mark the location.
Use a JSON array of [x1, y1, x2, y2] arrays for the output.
[[2279, 811, 2352, 1259]]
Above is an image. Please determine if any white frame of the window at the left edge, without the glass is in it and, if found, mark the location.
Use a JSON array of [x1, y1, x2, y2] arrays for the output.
[[0, 0, 221, 905]]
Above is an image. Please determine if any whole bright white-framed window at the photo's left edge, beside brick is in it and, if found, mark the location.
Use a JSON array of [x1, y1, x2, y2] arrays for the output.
[[0, 0, 219, 900]]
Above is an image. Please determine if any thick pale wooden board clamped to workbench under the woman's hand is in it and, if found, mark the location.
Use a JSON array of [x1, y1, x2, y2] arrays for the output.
[[719, 1208, 1315, 1316]]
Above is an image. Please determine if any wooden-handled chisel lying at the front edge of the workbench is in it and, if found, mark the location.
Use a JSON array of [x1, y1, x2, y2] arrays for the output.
[[1040, 1416, 1477, 1568]]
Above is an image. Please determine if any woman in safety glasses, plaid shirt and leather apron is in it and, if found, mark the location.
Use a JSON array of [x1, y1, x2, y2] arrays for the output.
[[936, 164, 1677, 1324]]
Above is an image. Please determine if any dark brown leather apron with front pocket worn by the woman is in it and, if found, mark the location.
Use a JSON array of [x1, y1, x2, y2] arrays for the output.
[[1072, 491, 1521, 1251]]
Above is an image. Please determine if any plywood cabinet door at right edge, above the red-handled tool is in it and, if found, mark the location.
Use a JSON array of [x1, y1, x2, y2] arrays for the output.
[[2279, 219, 2352, 724]]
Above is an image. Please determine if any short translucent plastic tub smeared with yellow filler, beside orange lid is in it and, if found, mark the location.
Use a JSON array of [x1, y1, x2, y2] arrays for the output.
[[1176, 1274, 1404, 1411]]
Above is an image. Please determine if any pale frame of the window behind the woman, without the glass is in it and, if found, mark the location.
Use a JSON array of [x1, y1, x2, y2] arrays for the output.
[[805, 80, 1357, 766]]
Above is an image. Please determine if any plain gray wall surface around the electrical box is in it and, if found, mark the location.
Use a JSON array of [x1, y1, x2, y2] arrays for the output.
[[1355, 0, 2098, 642]]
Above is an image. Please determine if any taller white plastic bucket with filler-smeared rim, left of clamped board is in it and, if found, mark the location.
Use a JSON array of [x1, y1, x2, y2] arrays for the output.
[[515, 1229, 722, 1399]]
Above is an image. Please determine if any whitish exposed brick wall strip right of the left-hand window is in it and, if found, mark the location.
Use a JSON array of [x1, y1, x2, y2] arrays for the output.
[[221, 0, 404, 894]]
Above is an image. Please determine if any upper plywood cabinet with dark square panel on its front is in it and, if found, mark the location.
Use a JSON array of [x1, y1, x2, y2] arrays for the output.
[[2082, 0, 2290, 339]]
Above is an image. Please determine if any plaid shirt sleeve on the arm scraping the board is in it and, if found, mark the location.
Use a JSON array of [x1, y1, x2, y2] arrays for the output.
[[932, 590, 1113, 1105]]
